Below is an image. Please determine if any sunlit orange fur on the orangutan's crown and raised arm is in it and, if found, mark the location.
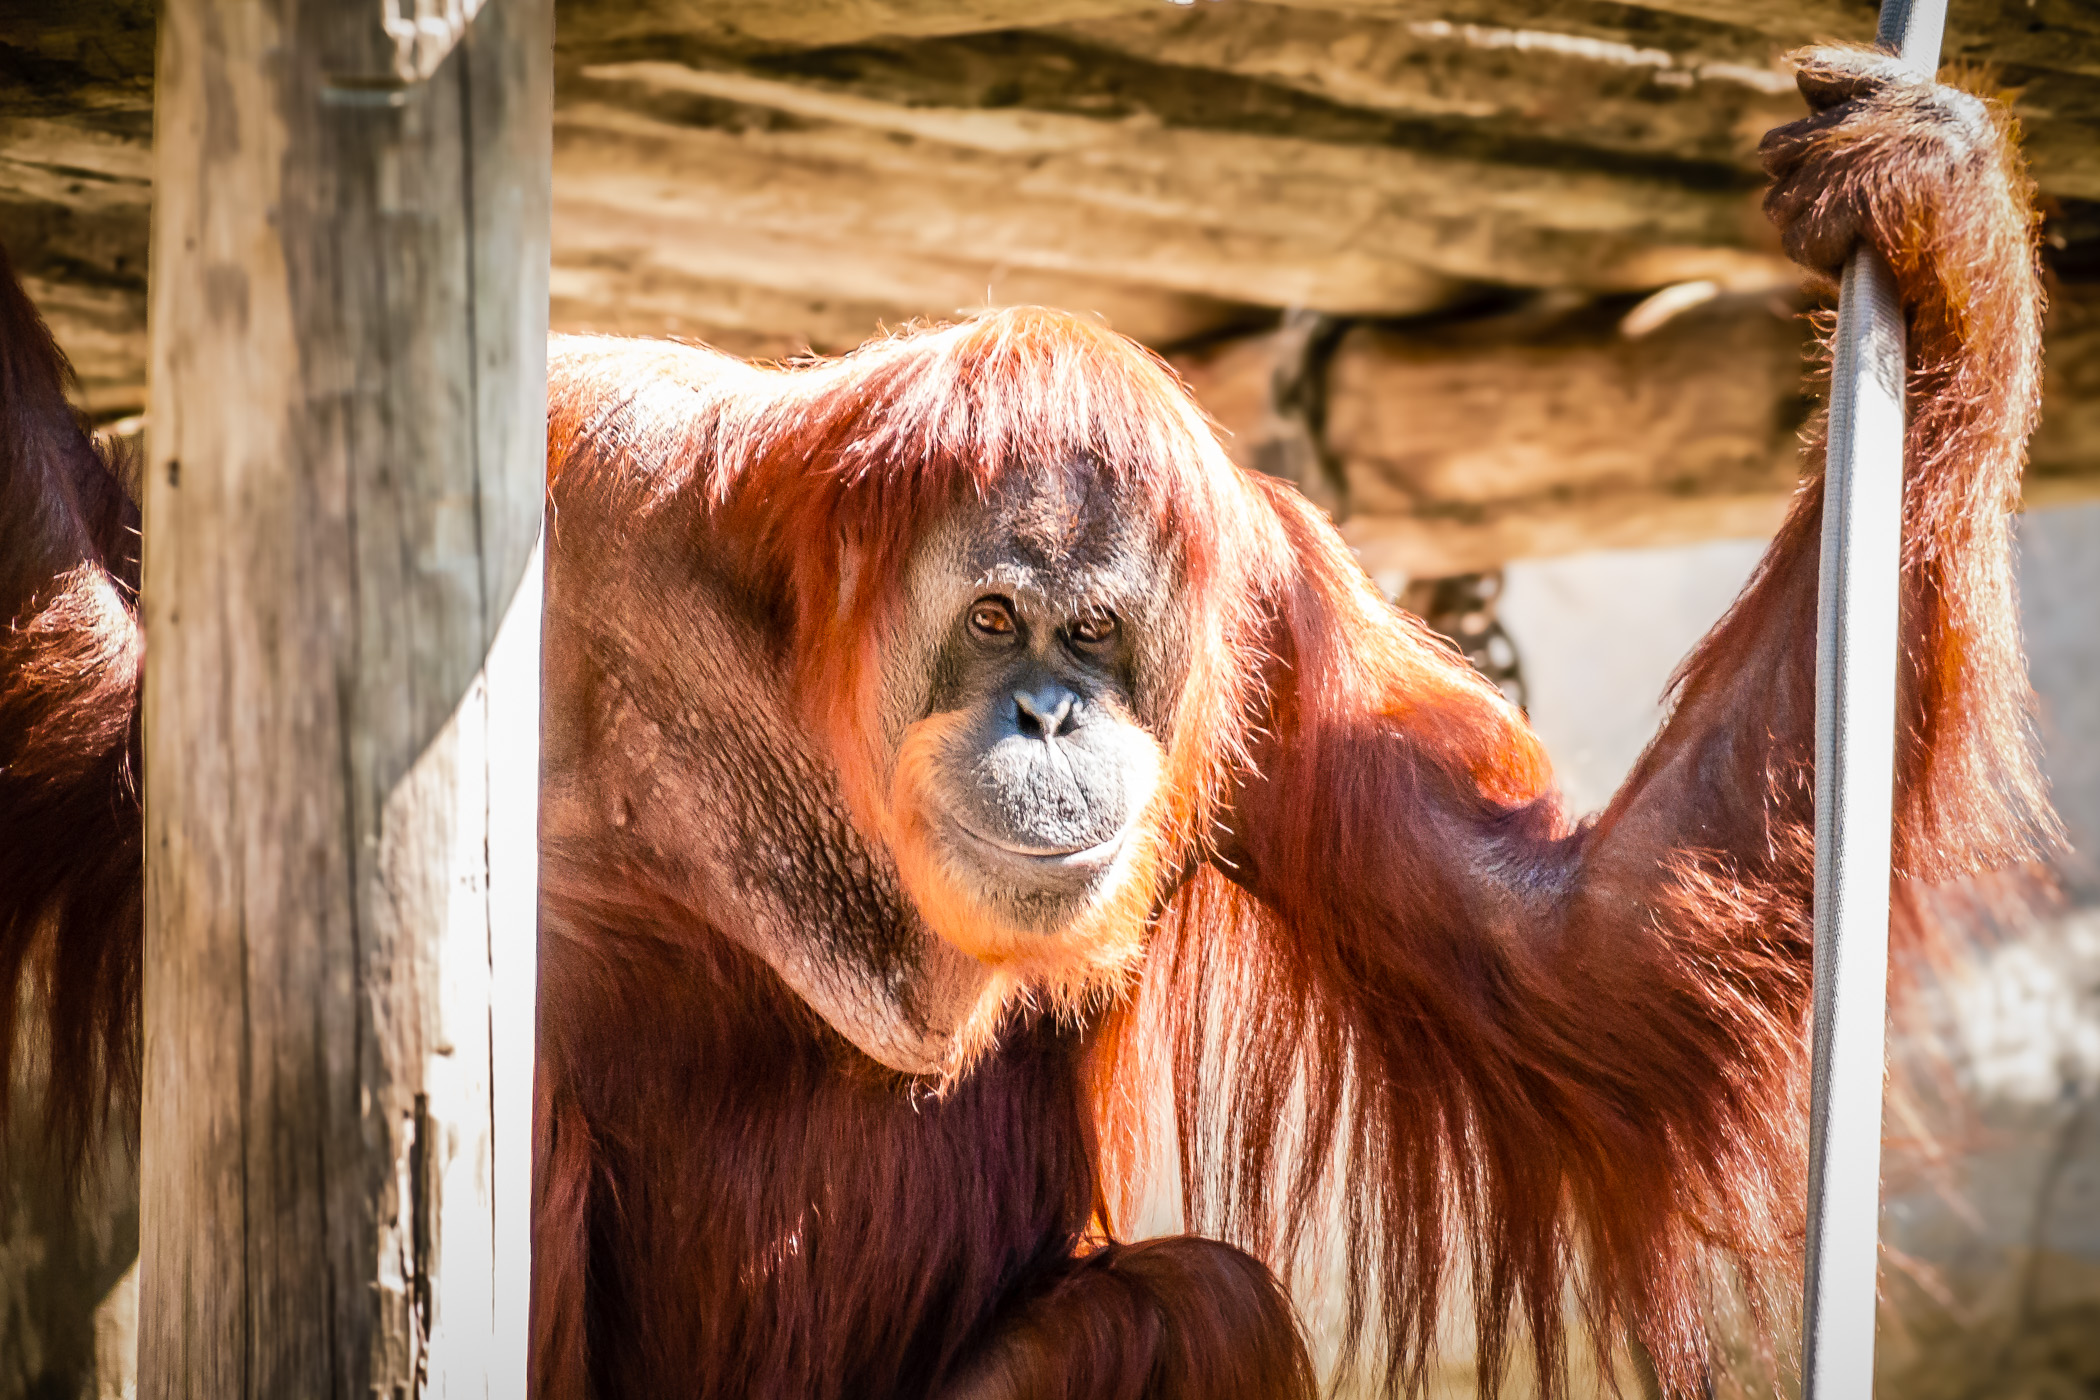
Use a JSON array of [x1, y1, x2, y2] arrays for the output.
[[529, 49, 2050, 1390]]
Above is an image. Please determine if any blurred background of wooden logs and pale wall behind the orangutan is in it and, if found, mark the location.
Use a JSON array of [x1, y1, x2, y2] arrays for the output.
[[12, 0, 2100, 1400]]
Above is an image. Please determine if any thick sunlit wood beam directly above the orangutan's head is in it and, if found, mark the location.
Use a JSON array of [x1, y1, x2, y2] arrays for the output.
[[557, 40, 1777, 338]]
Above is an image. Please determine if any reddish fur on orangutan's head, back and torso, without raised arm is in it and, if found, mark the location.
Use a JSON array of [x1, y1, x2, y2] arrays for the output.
[[536, 313, 1310, 1398]]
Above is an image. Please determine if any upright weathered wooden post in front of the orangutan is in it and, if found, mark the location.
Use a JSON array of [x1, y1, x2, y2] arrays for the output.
[[139, 0, 552, 1400]]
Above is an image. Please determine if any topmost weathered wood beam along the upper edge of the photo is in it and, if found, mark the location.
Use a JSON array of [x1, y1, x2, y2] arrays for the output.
[[563, 0, 2100, 199]]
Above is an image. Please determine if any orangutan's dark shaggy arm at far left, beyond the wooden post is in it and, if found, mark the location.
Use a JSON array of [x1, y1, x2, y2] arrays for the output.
[[0, 238, 143, 1169]]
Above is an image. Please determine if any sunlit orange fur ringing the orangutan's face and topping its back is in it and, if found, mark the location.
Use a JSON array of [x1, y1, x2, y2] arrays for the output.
[[550, 311, 1283, 1060]]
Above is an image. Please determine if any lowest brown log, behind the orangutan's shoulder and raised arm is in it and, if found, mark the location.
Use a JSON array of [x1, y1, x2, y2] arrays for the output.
[[1176, 285, 2100, 577]]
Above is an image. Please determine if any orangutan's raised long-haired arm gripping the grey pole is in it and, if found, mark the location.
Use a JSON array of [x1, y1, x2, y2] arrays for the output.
[[1218, 50, 2052, 1390]]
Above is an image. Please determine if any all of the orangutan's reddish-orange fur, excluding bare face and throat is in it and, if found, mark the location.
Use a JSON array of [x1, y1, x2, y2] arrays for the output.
[[0, 50, 2050, 1398]]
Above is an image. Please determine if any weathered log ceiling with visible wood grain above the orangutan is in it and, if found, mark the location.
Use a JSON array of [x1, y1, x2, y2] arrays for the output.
[[0, 0, 2100, 558]]
